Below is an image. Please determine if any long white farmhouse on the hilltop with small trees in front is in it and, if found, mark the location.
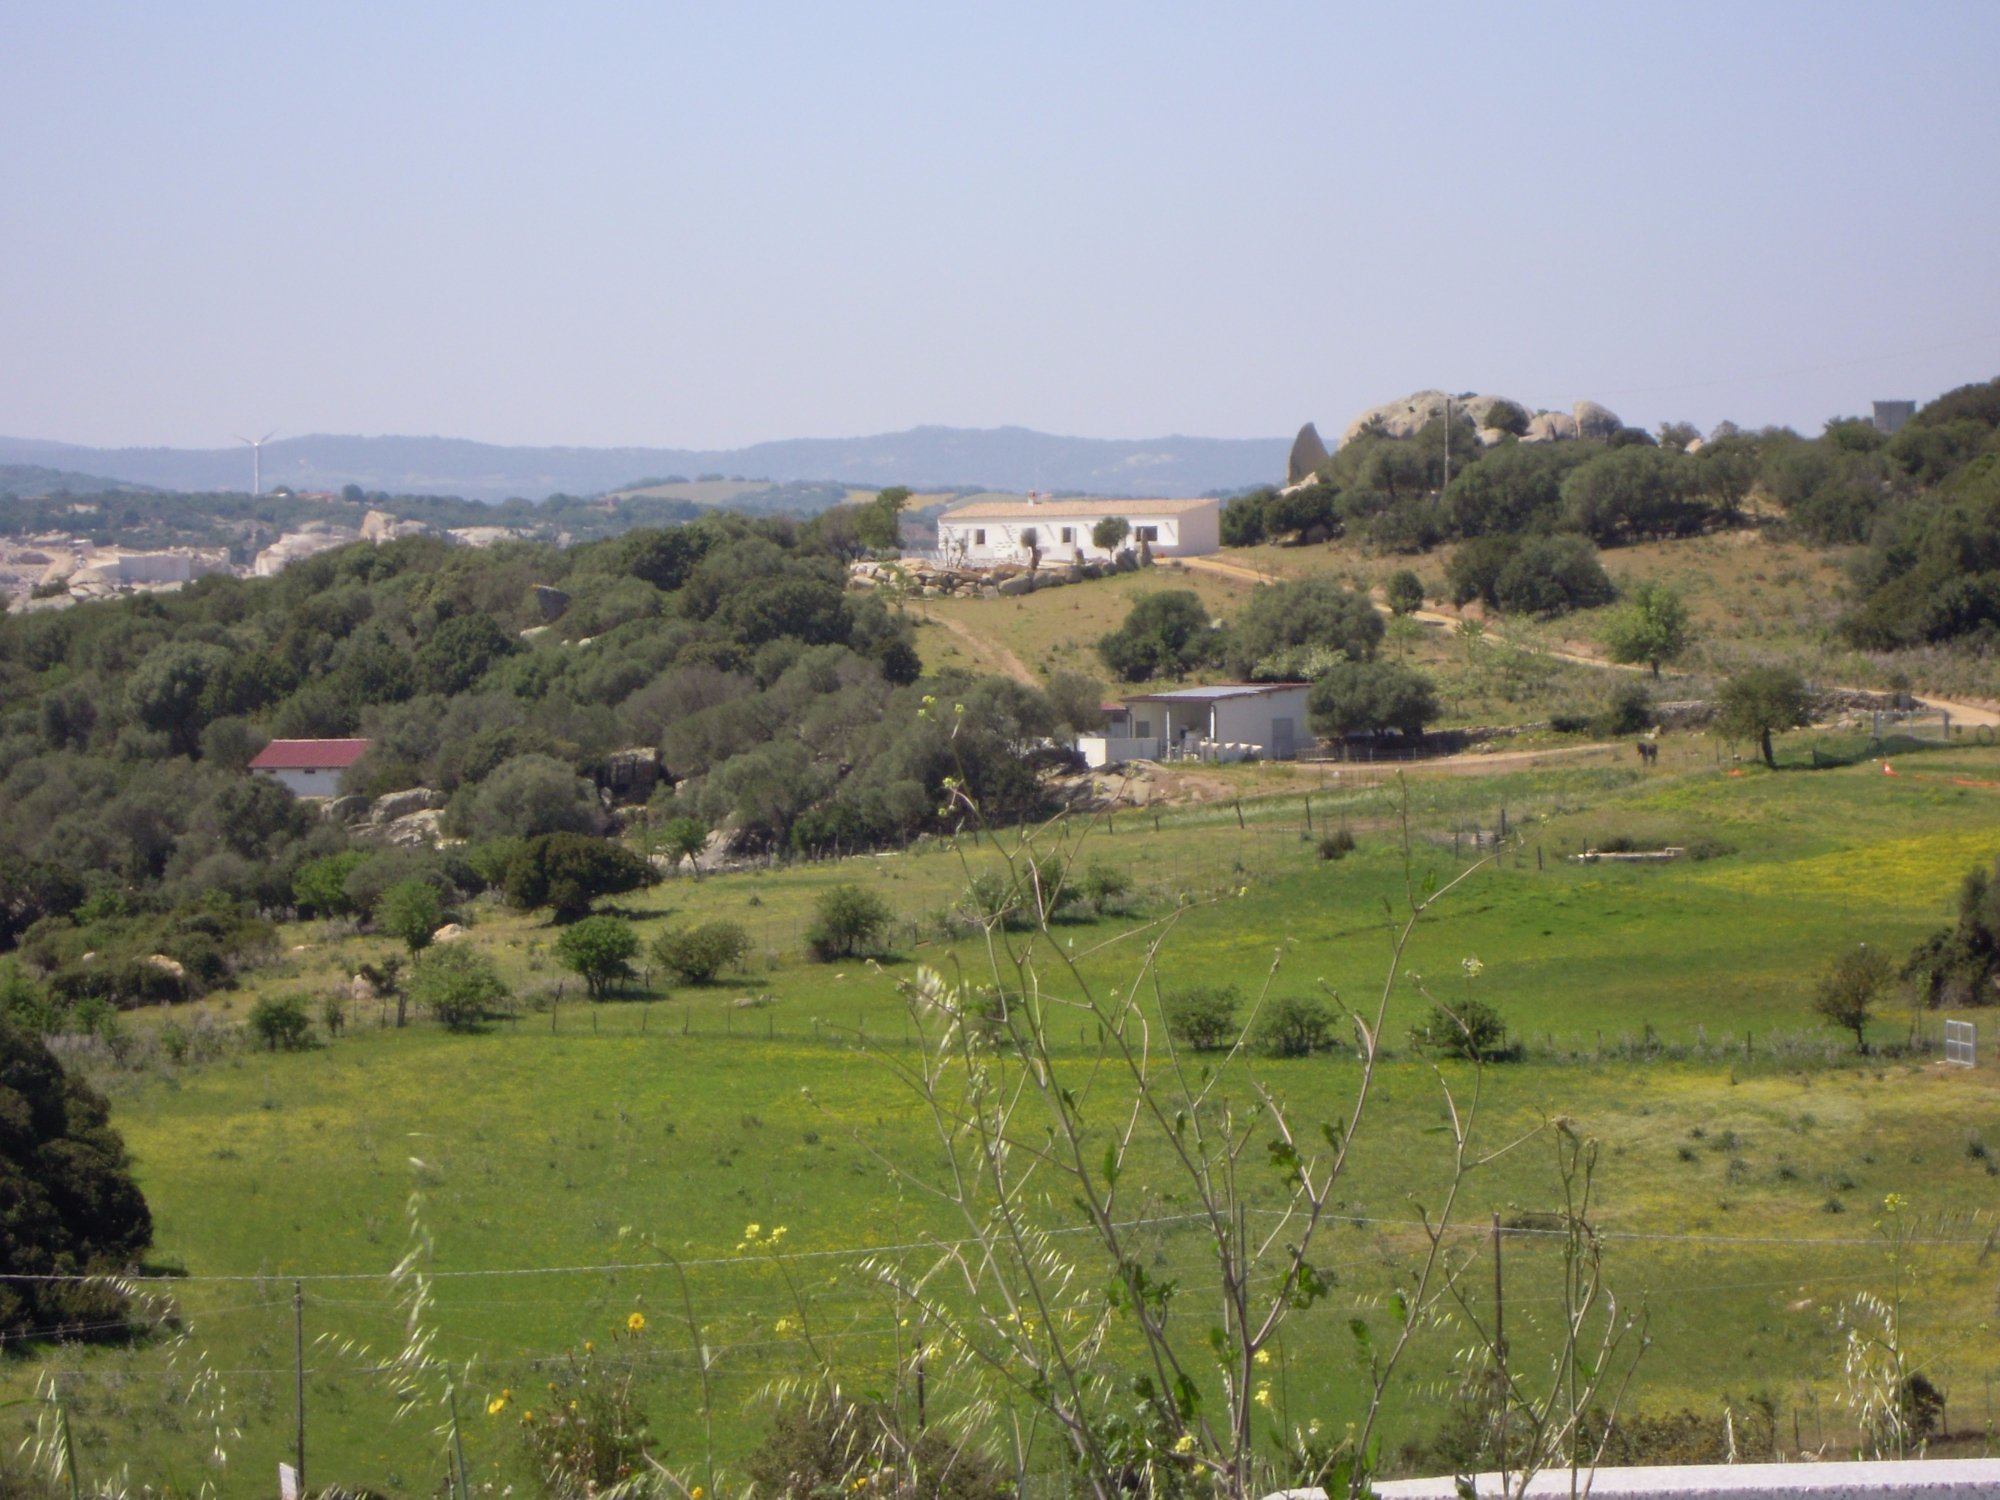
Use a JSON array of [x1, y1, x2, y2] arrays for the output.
[[938, 496, 1222, 566]]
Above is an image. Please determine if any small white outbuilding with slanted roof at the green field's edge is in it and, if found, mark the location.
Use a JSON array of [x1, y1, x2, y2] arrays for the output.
[[1076, 682, 1312, 766]]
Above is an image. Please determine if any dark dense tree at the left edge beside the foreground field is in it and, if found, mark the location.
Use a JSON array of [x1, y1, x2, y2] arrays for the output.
[[0, 1018, 152, 1338]]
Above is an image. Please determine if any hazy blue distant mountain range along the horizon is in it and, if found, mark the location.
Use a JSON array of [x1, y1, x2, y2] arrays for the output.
[[0, 428, 1290, 500]]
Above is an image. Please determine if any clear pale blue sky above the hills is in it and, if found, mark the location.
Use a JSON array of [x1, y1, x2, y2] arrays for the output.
[[0, 0, 2000, 448]]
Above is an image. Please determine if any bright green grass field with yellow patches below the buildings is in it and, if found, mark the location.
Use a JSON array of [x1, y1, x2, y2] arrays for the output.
[[4, 736, 2000, 1496]]
